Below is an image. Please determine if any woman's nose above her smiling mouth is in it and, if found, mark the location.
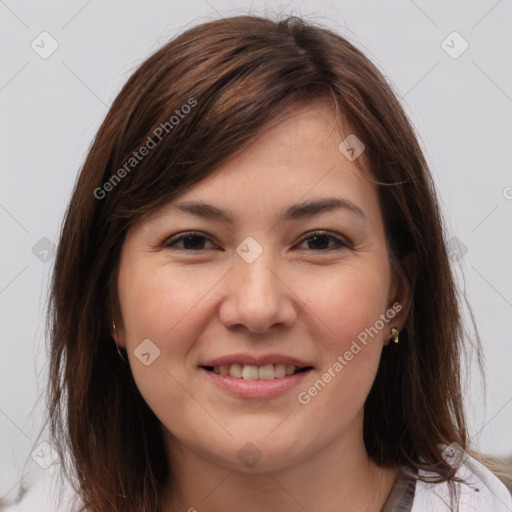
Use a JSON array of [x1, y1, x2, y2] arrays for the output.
[[219, 251, 297, 333]]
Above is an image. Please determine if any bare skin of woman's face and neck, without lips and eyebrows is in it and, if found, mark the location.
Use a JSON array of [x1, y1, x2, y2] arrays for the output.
[[116, 103, 408, 512]]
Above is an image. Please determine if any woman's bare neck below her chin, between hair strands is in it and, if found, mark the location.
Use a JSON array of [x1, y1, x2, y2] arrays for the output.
[[161, 418, 398, 512]]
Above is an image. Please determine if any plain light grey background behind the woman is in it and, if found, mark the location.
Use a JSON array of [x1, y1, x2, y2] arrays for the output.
[[0, 0, 512, 508]]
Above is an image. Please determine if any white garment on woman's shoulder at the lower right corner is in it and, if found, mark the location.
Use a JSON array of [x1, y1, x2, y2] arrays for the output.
[[411, 454, 512, 512]]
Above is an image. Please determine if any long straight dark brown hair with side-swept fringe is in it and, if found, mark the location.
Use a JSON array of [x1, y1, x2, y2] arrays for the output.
[[48, 16, 484, 512]]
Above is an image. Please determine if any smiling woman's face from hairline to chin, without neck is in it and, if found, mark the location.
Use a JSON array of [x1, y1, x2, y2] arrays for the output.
[[117, 103, 405, 472]]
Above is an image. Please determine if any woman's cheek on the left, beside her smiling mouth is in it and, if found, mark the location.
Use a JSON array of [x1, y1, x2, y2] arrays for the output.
[[118, 260, 218, 425]]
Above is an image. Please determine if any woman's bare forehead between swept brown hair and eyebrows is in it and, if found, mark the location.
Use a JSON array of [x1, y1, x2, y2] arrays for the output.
[[144, 103, 380, 228]]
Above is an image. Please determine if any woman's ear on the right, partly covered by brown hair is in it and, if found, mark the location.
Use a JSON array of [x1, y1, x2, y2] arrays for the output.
[[384, 252, 417, 345]]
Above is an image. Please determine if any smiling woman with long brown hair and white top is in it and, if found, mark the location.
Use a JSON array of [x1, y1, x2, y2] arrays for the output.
[[42, 16, 512, 512]]
